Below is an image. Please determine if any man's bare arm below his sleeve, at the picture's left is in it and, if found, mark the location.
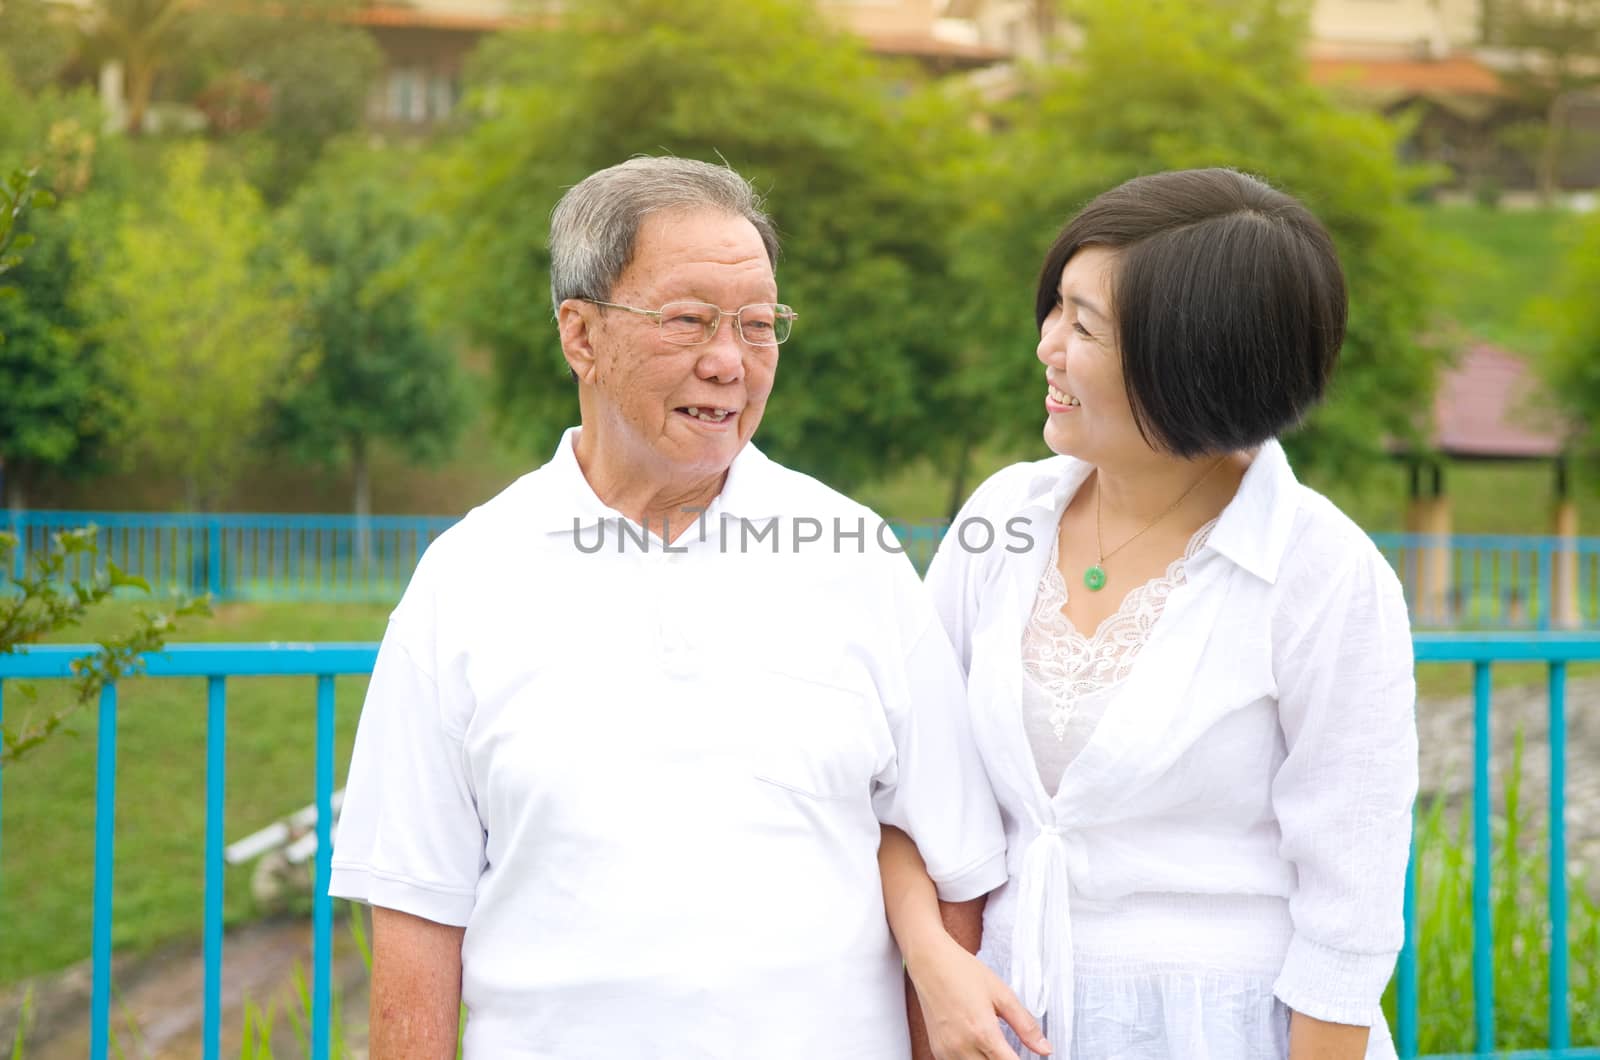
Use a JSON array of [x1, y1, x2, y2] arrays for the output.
[[368, 906, 467, 1060]]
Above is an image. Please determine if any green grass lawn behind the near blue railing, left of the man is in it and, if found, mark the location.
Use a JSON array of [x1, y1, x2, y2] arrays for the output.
[[0, 605, 389, 982]]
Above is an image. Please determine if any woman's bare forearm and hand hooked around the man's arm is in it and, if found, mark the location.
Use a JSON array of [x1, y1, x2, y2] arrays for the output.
[[878, 826, 1050, 1060]]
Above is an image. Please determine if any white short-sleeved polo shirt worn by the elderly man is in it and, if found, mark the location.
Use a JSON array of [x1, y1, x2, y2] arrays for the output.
[[331, 429, 1006, 1060]]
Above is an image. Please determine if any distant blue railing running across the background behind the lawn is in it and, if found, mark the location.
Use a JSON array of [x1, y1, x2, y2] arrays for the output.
[[0, 511, 1600, 629]]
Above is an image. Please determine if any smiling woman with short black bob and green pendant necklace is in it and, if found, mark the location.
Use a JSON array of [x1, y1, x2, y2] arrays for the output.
[[885, 170, 1416, 1060]]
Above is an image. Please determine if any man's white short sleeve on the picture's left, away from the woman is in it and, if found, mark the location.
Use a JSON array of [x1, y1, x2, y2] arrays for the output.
[[328, 620, 485, 927]]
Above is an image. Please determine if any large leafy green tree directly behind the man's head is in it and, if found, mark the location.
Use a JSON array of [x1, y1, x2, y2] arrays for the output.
[[429, 0, 960, 485]]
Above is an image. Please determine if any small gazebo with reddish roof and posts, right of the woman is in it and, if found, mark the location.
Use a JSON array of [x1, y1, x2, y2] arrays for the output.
[[1398, 343, 1581, 626]]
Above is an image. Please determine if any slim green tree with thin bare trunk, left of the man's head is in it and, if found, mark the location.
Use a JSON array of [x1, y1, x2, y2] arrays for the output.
[[275, 152, 467, 519]]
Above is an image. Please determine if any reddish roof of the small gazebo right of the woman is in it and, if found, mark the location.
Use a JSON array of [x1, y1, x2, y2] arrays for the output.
[[1432, 343, 1565, 458]]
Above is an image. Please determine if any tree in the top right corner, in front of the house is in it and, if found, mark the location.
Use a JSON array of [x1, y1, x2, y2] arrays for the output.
[[1483, 0, 1600, 202]]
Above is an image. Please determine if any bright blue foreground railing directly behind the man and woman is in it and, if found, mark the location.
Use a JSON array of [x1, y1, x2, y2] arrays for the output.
[[0, 632, 1600, 1060]]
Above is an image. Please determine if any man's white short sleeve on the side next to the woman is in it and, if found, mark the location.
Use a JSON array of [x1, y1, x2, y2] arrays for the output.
[[872, 575, 1006, 901]]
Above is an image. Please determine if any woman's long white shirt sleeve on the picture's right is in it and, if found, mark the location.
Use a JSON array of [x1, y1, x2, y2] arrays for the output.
[[1272, 551, 1418, 1026]]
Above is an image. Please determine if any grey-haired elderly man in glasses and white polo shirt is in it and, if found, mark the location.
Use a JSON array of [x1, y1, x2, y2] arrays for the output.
[[333, 159, 1006, 1060]]
